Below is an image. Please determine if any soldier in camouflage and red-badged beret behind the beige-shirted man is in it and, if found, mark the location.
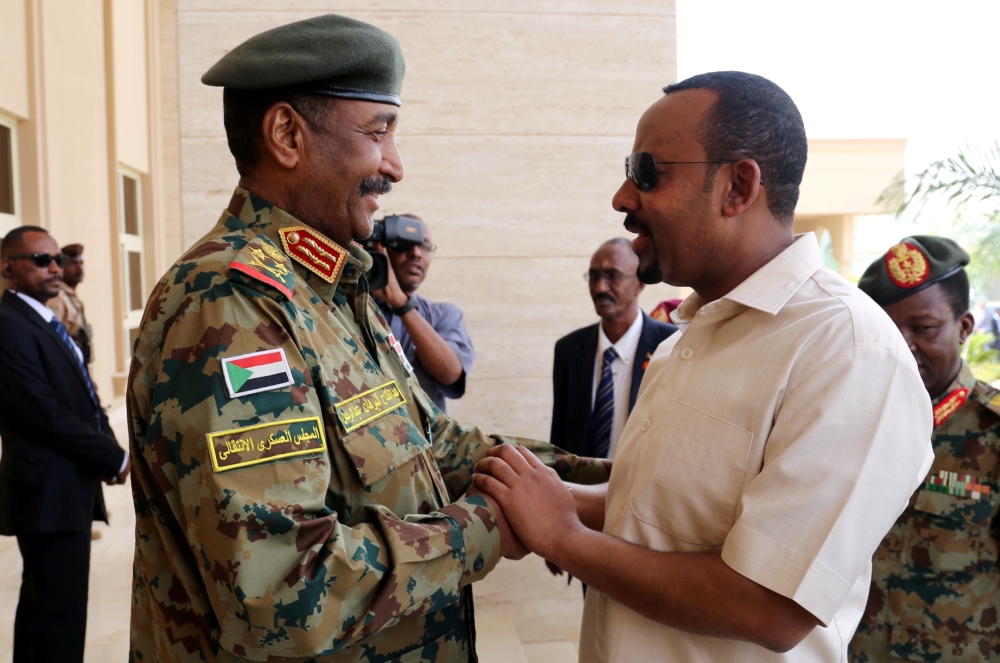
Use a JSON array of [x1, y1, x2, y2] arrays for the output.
[[850, 236, 1000, 663]]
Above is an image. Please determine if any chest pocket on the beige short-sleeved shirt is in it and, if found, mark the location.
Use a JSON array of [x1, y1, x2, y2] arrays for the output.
[[629, 400, 753, 547]]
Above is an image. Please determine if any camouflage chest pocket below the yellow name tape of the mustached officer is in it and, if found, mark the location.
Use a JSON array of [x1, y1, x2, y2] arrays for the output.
[[340, 405, 430, 487]]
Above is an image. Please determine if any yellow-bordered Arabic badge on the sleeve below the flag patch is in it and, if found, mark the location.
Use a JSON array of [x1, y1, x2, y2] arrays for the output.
[[208, 417, 326, 472]]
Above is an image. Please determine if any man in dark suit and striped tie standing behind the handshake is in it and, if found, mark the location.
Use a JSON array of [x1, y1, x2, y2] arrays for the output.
[[549, 238, 677, 458]]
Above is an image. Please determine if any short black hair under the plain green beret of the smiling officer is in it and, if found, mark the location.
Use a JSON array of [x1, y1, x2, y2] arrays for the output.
[[222, 87, 336, 177]]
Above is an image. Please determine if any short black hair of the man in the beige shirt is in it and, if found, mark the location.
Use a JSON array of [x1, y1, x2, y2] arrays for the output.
[[663, 71, 809, 225]]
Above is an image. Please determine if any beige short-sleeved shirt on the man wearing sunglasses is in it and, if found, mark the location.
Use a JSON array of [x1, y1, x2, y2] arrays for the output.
[[580, 233, 934, 663]]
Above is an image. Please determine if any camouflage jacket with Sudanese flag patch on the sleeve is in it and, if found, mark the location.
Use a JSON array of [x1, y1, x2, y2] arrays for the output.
[[128, 189, 607, 663]]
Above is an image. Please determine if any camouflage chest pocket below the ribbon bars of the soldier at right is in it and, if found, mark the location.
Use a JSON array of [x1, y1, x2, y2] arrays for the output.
[[909, 486, 996, 572]]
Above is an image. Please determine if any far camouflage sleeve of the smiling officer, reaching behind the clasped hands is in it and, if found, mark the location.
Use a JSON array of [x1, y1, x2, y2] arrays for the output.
[[410, 380, 611, 499]]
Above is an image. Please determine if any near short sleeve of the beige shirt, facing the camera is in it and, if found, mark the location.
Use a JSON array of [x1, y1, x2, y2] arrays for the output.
[[722, 344, 934, 625]]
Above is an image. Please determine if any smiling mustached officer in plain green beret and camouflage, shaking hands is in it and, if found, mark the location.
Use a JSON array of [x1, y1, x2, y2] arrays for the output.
[[128, 16, 607, 663]]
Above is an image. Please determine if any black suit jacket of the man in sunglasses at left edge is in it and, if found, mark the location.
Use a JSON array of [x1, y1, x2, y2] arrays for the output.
[[0, 291, 125, 536]]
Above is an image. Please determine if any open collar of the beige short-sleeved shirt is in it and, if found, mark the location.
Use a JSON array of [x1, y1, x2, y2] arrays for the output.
[[670, 232, 823, 327]]
